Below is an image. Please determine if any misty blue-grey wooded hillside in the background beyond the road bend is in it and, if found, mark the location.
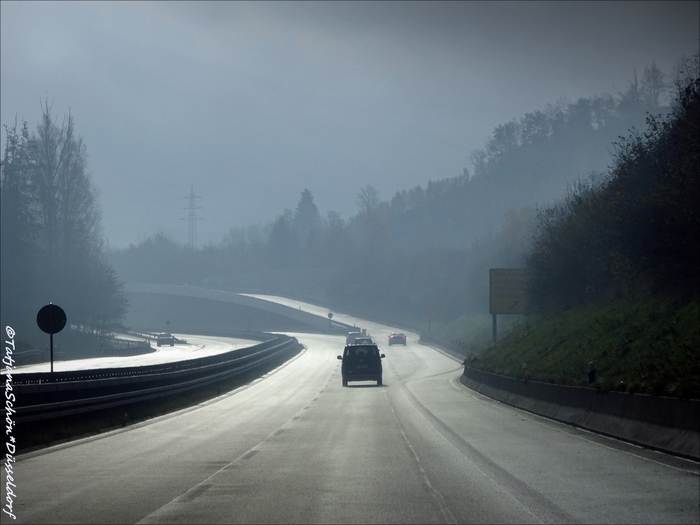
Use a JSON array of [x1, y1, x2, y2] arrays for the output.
[[110, 60, 697, 332]]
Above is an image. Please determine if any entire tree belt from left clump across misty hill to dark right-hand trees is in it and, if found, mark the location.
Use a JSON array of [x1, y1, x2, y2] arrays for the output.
[[1, 59, 698, 346]]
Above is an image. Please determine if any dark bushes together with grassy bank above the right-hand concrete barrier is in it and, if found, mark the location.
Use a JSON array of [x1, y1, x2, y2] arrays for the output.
[[466, 57, 700, 399]]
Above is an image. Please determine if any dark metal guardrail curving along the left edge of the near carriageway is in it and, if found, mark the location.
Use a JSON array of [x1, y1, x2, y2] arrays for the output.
[[4, 335, 299, 423]]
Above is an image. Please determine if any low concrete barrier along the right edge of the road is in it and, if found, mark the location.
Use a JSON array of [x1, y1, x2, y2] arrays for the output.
[[460, 366, 700, 460]]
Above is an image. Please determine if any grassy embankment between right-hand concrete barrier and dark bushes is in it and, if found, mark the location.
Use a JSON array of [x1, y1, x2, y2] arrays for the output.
[[454, 299, 700, 399]]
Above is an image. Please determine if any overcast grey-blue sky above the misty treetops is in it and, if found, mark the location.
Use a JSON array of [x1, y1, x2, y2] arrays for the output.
[[0, 1, 700, 248]]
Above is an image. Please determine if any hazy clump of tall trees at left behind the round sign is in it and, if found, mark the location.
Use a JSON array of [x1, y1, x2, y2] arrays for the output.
[[0, 103, 127, 348]]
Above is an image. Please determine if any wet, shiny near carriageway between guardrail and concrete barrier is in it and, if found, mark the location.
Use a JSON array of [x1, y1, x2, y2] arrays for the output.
[[2, 304, 700, 524]]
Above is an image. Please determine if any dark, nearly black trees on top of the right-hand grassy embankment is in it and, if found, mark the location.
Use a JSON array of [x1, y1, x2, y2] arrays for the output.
[[526, 57, 700, 311]]
